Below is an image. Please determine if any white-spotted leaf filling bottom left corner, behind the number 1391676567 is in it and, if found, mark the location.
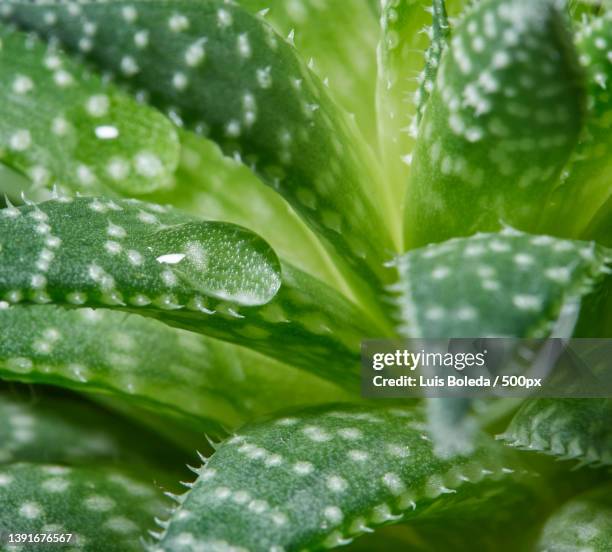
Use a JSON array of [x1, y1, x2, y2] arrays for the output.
[[0, 463, 164, 552]]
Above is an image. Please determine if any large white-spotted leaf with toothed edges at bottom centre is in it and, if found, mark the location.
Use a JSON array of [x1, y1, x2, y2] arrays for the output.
[[153, 407, 532, 552]]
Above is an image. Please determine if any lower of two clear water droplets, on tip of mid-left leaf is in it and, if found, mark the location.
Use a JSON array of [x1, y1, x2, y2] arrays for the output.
[[149, 222, 281, 306]]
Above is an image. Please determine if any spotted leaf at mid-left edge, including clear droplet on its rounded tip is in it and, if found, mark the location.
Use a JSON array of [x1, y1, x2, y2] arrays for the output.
[[0, 197, 280, 306]]
